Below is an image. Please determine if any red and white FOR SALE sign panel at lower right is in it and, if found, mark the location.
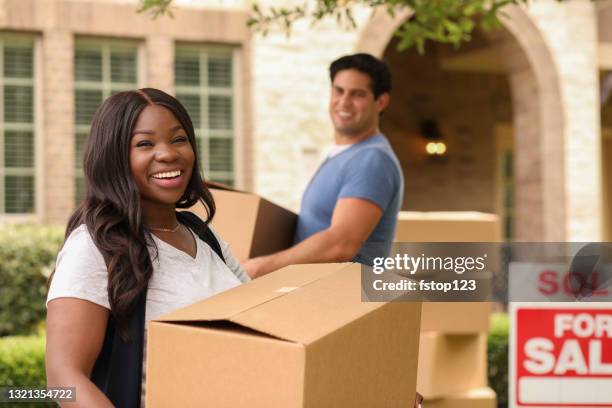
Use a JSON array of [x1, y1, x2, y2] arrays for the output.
[[509, 303, 612, 407]]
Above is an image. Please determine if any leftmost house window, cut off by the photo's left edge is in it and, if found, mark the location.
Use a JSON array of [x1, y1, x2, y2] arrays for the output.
[[0, 35, 35, 214]]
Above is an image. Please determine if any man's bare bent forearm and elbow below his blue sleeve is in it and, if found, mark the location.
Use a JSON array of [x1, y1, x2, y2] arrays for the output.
[[242, 198, 383, 278]]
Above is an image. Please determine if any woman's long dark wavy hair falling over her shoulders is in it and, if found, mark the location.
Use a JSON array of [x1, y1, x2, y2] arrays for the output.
[[64, 88, 215, 338]]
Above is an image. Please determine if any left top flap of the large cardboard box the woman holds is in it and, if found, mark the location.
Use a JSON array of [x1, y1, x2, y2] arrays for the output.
[[155, 264, 346, 326]]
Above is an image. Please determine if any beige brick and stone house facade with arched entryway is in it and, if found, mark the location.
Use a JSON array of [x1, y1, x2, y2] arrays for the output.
[[0, 0, 612, 241]]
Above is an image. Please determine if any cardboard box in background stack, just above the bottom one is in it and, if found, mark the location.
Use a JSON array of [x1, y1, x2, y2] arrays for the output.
[[417, 333, 487, 399]]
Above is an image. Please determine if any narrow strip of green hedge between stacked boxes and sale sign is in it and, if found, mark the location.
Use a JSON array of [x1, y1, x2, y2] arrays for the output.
[[487, 313, 509, 407]]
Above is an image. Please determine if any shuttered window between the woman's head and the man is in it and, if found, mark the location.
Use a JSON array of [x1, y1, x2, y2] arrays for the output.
[[174, 45, 236, 186]]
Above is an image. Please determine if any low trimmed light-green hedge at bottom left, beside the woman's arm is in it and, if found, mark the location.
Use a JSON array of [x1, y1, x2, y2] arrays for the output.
[[0, 336, 57, 408]]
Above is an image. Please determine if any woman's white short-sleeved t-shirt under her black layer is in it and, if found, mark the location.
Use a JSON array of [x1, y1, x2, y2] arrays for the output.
[[47, 224, 250, 406]]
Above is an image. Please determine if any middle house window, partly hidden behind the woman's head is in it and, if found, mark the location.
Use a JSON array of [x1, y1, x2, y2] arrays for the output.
[[74, 39, 138, 204]]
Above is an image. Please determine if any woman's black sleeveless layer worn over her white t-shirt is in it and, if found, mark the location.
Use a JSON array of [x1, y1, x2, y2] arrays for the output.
[[91, 211, 225, 408]]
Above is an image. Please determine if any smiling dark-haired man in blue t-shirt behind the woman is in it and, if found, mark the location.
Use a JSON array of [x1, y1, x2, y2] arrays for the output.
[[243, 54, 404, 278]]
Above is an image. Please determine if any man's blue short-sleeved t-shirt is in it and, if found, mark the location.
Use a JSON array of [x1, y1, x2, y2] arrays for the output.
[[295, 134, 404, 265]]
